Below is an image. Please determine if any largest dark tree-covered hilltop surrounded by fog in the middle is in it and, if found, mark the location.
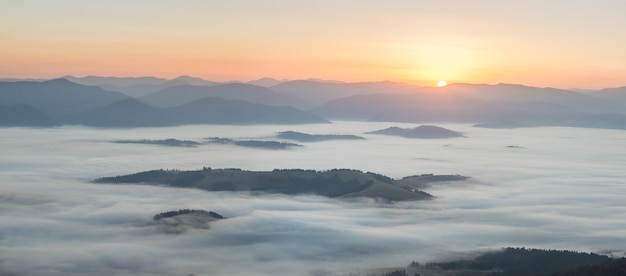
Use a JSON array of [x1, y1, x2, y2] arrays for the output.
[[94, 168, 467, 201]]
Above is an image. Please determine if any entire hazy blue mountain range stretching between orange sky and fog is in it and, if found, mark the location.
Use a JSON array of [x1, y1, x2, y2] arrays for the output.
[[0, 77, 626, 129]]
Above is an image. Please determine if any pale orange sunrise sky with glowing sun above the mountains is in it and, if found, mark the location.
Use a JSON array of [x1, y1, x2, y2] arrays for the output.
[[0, 0, 626, 89]]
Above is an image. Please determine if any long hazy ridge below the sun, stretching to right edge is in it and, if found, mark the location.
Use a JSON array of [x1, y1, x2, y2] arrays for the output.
[[312, 86, 626, 129]]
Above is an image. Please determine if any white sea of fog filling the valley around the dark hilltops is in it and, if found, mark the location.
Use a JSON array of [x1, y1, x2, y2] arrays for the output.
[[0, 122, 626, 275]]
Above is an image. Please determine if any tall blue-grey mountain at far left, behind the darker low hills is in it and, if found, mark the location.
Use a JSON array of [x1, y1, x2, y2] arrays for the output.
[[0, 79, 128, 119]]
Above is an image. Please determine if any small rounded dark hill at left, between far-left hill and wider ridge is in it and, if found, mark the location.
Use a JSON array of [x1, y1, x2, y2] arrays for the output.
[[63, 99, 174, 127]]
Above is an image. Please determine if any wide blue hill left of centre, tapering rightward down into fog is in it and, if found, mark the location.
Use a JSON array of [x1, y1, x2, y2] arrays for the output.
[[166, 97, 328, 124]]
